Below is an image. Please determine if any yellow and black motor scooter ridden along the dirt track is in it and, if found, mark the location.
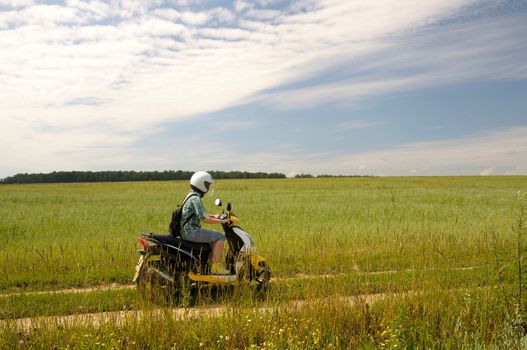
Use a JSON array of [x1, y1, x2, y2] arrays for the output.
[[133, 199, 271, 300]]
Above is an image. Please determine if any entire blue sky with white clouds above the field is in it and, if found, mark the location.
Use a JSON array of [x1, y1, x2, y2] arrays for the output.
[[0, 0, 527, 178]]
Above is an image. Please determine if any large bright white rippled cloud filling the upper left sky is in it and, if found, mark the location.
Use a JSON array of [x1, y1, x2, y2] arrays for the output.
[[0, 0, 486, 129]]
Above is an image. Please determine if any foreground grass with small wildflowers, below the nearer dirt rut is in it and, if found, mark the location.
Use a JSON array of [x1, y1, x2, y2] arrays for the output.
[[0, 290, 527, 349]]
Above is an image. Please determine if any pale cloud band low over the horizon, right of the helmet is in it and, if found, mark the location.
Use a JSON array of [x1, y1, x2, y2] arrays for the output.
[[217, 127, 527, 176]]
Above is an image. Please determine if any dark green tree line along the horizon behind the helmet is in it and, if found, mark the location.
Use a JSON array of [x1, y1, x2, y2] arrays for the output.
[[0, 170, 286, 184]]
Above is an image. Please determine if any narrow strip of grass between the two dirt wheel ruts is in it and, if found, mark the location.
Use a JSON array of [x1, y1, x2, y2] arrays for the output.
[[0, 269, 495, 319]]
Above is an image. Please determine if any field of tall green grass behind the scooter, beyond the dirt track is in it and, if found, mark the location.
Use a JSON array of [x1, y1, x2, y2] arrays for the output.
[[0, 177, 527, 290]]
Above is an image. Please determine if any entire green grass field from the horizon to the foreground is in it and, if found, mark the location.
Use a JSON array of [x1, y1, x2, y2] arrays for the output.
[[0, 177, 527, 349]]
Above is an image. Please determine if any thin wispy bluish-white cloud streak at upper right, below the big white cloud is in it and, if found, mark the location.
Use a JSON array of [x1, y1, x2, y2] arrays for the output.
[[264, 14, 527, 108]]
